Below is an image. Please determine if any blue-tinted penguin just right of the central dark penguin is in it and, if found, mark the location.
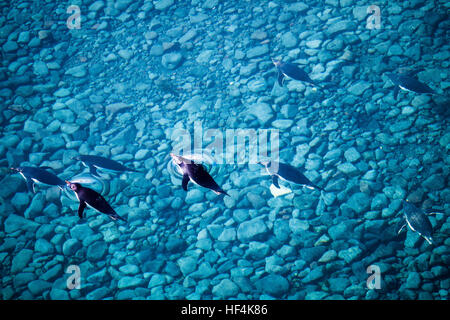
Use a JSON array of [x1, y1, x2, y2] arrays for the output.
[[260, 161, 322, 191]]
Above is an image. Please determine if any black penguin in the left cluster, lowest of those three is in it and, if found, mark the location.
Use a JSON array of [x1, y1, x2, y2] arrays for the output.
[[66, 180, 126, 221]]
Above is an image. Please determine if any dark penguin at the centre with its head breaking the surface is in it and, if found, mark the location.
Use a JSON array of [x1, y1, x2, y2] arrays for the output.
[[170, 153, 229, 196]]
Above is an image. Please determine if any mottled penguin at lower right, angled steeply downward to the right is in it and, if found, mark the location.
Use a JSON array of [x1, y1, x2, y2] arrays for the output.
[[397, 200, 433, 244]]
